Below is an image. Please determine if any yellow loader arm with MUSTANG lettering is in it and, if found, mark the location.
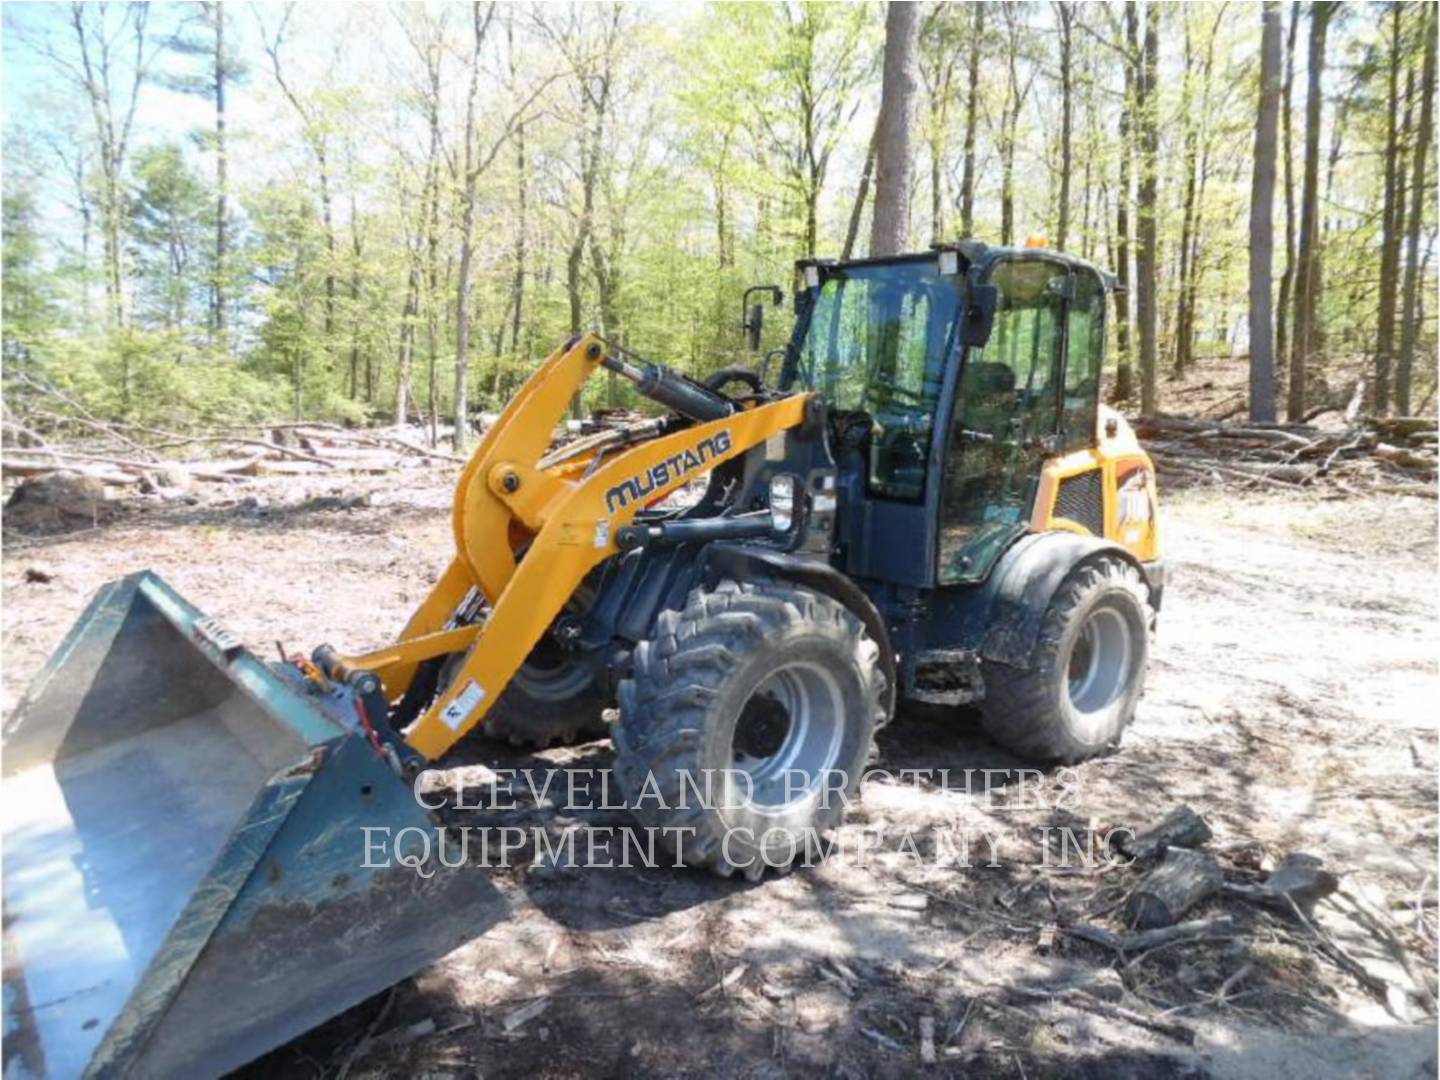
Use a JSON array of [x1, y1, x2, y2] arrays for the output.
[[341, 334, 809, 759]]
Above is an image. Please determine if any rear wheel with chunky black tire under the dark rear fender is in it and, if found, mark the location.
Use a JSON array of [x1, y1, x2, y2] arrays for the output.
[[981, 556, 1155, 765]]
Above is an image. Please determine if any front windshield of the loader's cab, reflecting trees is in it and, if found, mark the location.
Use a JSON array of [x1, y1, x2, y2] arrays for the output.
[[793, 259, 959, 500]]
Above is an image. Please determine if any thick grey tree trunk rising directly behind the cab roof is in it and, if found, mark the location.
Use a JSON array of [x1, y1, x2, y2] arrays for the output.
[[870, 0, 920, 256]]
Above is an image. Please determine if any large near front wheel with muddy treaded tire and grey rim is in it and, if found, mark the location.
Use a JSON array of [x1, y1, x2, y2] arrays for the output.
[[613, 579, 886, 880]]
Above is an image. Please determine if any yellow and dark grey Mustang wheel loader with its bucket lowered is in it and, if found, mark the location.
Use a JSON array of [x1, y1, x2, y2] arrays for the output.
[[3, 242, 1165, 1076]]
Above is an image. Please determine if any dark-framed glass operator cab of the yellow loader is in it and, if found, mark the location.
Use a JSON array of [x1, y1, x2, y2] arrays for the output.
[[780, 242, 1110, 588]]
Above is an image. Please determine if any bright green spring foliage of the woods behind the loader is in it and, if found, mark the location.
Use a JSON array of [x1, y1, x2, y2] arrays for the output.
[[3, 0, 1436, 426]]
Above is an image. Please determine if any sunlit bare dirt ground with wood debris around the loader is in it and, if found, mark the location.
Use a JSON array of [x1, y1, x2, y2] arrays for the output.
[[3, 469, 1440, 1080]]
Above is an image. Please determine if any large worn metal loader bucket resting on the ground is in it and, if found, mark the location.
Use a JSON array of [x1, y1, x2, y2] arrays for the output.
[[0, 573, 507, 1077]]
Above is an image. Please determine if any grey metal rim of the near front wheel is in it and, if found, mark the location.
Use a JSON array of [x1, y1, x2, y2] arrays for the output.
[[732, 662, 845, 812]]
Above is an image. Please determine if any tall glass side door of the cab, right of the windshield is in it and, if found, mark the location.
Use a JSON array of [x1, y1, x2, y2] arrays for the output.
[[936, 255, 1074, 585]]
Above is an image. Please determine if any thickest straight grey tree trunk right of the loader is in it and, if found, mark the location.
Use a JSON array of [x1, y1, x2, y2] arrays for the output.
[[1250, 0, 1282, 422]]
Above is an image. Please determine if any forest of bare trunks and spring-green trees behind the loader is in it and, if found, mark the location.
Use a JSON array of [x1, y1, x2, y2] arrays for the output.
[[3, 1, 1437, 449]]
